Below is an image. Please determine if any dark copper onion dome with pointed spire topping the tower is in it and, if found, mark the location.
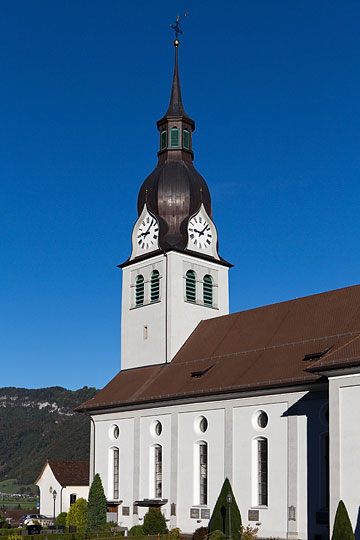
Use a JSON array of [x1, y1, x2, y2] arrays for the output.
[[137, 39, 212, 251]]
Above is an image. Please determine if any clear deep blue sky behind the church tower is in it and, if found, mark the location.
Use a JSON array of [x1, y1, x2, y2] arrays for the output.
[[0, 0, 360, 389]]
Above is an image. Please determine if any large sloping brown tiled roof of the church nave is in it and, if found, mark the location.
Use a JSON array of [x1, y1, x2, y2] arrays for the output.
[[77, 285, 360, 411]]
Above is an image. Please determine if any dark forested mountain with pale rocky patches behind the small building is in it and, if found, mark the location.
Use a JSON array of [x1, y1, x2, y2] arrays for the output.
[[0, 386, 97, 484]]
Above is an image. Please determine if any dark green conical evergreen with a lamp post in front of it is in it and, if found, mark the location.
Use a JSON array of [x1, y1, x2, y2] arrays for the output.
[[209, 478, 241, 540]]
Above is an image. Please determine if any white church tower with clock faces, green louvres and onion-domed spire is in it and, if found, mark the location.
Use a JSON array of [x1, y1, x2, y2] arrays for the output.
[[120, 39, 231, 369]]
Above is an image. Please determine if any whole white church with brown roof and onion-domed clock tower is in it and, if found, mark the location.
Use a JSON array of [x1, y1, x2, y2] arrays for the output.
[[77, 35, 360, 540]]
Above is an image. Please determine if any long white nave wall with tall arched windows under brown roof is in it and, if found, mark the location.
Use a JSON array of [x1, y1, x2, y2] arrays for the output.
[[90, 386, 326, 539]]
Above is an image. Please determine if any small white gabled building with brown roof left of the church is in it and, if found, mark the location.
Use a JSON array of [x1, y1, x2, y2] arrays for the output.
[[35, 459, 89, 517]]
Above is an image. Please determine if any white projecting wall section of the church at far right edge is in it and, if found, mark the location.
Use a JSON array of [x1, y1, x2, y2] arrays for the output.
[[329, 374, 360, 538]]
